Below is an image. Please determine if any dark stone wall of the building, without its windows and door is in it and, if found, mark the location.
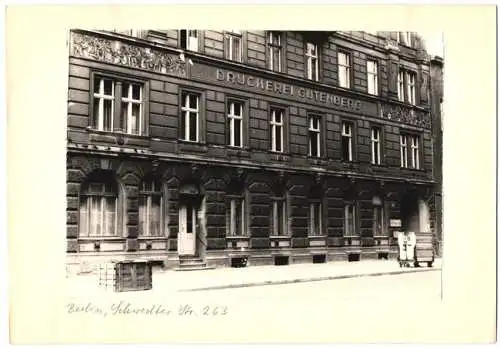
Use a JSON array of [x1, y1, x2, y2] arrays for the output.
[[67, 30, 440, 274]]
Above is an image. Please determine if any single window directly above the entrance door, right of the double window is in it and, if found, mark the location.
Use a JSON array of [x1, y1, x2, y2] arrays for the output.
[[180, 92, 200, 142]]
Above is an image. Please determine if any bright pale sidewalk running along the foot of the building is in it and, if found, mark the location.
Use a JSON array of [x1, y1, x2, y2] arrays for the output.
[[67, 259, 442, 295]]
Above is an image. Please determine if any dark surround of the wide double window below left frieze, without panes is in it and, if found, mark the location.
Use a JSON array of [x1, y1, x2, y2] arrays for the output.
[[88, 69, 150, 138]]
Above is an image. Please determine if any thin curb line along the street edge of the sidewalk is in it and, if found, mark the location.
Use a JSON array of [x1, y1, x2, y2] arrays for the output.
[[178, 268, 441, 292]]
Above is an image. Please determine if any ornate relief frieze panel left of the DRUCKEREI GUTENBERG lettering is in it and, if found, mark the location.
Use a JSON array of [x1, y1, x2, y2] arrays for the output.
[[70, 32, 186, 76]]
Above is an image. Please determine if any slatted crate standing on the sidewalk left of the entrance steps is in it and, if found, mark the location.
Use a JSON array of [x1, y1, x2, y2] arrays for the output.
[[99, 260, 153, 292]]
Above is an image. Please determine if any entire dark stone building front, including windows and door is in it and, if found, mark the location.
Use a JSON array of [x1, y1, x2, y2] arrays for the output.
[[66, 30, 442, 271]]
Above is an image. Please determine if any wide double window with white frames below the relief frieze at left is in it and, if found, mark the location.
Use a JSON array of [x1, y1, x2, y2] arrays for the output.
[[93, 76, 147, 135]]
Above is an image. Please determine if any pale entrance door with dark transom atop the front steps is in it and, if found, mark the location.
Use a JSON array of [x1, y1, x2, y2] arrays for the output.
[[178, 202, 199, 256]]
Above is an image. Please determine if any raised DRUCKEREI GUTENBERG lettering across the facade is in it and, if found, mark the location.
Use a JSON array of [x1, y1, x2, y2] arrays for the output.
[[216, 69, 361, 111]]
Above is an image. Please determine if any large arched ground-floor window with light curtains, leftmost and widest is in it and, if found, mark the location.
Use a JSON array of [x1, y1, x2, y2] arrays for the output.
[[79, 171, 118, 237]]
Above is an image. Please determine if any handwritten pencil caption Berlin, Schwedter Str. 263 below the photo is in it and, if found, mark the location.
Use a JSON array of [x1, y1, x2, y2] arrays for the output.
[[66, 301, 228, 317]]
